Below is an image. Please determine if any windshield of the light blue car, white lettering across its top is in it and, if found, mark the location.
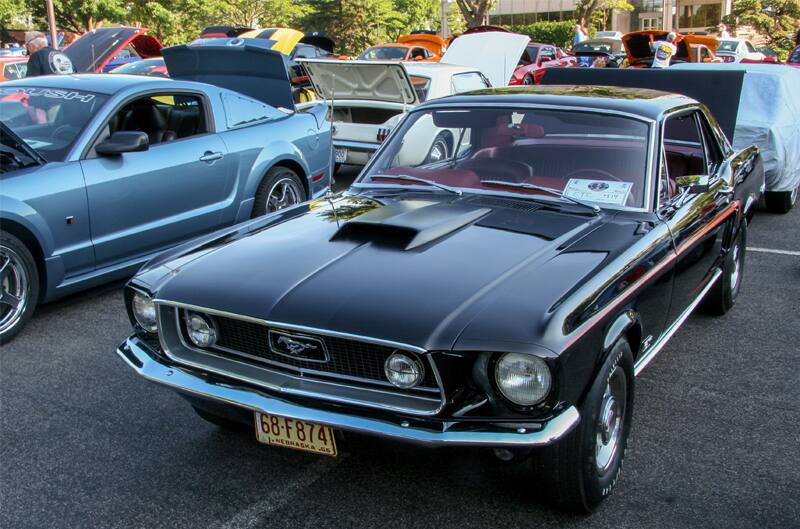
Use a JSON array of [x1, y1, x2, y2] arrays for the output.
[[0, 87, 108, 162]]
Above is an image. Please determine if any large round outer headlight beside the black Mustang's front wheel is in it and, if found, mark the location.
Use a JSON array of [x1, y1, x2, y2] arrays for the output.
[[494, 353, 552, 406]]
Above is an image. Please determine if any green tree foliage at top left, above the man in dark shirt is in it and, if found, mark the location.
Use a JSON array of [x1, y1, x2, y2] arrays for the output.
[[28, 0, 127, 33]]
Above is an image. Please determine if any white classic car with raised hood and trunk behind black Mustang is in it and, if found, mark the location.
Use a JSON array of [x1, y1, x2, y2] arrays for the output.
[[302, 32, 530, 166]]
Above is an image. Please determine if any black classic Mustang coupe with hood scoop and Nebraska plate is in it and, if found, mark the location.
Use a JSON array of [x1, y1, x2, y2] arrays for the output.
[[118, 86, 764, 511]]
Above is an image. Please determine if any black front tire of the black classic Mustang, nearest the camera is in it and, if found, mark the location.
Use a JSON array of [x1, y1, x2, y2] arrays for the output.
[[531, 339, 634, 513]]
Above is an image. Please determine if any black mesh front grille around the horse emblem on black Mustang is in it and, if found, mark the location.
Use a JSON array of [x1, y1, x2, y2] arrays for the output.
[[187, 316, 438, 390]]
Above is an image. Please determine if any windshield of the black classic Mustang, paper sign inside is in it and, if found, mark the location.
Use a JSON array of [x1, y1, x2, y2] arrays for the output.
[[357, 108, 649, 208]]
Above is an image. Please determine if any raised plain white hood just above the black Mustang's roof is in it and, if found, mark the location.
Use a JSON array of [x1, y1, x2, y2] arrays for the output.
[[440, 31, 531, 88]]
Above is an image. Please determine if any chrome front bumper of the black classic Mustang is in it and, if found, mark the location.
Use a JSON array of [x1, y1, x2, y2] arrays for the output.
[[117, 337, 580, 447]]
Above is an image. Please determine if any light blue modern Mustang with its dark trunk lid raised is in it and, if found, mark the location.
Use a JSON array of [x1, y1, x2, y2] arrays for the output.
[[0, 38, 331, 343]]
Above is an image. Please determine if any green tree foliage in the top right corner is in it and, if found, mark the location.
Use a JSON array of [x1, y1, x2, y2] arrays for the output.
[[723, 0, 800, 58]]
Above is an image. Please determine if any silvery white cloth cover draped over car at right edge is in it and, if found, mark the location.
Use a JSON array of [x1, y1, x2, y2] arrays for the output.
[[670, 63, 800, 191]]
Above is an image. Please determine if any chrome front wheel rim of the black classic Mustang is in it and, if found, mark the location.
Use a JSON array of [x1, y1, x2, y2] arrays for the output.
[[595, 366, 628, 474]]
